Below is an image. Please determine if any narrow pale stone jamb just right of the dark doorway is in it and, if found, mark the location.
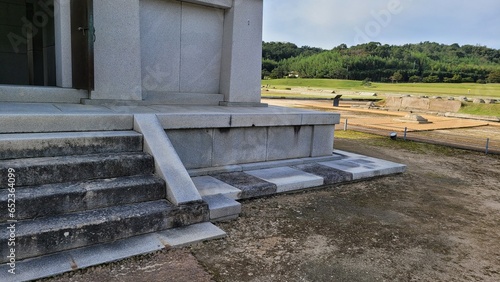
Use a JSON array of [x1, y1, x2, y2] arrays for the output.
[[54, 0, 73, 88]]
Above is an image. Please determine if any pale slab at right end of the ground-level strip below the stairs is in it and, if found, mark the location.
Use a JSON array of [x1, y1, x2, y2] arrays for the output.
[[157, 222, 226, 248]]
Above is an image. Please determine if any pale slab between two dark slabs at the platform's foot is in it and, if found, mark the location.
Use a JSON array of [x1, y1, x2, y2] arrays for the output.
[[246, 167, 324, 193]]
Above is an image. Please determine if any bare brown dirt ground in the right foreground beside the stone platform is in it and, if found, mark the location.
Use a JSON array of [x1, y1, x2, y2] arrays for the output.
[[46, 136, 500, 282]]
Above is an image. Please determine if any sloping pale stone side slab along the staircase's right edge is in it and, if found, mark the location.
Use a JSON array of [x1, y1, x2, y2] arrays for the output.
[[134, 114, 202, 205]]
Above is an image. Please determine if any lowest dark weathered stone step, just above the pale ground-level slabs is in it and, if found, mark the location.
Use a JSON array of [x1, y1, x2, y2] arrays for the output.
[[0, 200, 209, 264]]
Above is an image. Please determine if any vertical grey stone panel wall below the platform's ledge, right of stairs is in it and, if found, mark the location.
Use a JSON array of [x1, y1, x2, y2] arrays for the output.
[[166, 125, 334, 169]]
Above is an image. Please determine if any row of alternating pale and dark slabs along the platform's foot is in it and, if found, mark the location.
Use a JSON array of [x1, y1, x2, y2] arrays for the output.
[[189, 150, 406, 221]]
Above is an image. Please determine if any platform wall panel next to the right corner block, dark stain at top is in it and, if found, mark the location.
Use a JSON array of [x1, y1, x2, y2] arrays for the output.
[[266, 126, 312, 161]]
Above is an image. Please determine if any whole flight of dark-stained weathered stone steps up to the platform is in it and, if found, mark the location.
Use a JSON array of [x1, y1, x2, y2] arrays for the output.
[[0, 131, 209, 263]]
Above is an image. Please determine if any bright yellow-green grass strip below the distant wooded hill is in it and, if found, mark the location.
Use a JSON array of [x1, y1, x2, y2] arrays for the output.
[[262, 78, 500, 98]]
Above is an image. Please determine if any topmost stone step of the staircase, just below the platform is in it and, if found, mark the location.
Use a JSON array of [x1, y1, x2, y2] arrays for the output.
[[0, 131, 142, 160]]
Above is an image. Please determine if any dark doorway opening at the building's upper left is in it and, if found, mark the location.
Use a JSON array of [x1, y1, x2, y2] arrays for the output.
[[0, 0, 56, 86]]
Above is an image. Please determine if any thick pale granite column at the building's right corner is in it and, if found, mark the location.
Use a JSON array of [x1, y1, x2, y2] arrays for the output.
[[220, 0, 265, 106]]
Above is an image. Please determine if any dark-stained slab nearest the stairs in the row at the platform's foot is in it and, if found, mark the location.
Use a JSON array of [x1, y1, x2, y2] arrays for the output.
[[212, 172, 277, 199]]
